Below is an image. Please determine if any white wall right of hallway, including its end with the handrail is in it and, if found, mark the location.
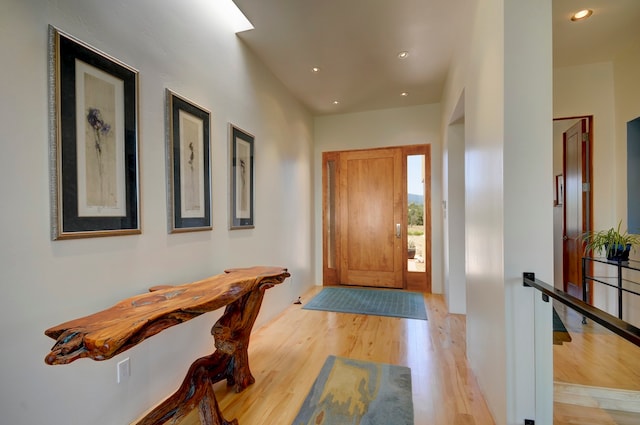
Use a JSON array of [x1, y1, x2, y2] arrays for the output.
[[443, 0, 553, 425]]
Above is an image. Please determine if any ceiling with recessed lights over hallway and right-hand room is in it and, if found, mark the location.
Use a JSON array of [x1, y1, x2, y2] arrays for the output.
[[234, 0, 640, 115]]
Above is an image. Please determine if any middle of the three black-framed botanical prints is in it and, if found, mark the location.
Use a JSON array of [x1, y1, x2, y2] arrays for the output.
[[166, 89, 212, 233]]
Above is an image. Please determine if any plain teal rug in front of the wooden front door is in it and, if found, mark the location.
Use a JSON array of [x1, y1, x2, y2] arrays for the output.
[[303, 287, 427, 320]]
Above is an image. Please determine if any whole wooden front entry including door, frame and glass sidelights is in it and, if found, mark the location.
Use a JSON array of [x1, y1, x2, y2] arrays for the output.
[[322, 144, 431, 292]]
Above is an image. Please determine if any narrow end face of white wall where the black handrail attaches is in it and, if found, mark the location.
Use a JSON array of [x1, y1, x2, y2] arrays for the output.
[[504, 0, 553, 423]]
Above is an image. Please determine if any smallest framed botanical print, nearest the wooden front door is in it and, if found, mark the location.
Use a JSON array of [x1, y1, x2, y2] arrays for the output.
[[229, 124, 255, 230]]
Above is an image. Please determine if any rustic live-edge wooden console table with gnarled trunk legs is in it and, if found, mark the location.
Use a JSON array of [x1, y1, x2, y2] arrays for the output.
[[45, 266, 290, 425]]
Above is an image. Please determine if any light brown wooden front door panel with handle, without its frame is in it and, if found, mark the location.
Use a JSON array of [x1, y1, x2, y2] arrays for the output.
[[338, 148, 406, 288]]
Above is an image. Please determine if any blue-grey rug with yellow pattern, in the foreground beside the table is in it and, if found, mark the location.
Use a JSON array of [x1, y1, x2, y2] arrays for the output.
[[292, 356, 413, 425]]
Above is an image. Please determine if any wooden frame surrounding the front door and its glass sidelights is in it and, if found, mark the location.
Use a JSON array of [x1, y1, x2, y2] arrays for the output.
[[322, 144, 432, 293]]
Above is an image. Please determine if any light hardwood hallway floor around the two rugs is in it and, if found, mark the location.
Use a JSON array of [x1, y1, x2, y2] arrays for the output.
[[174, 287, 494, 425]]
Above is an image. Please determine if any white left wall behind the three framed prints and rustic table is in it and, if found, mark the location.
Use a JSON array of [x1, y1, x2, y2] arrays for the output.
[[0, 0, 315, 425]]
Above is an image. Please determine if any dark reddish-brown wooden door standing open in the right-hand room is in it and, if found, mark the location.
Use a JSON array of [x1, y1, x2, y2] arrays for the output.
[[562, 119, 590, 298]]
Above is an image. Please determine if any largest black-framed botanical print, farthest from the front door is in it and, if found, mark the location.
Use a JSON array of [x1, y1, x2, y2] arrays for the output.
[[49, 26, 141, 240]]
